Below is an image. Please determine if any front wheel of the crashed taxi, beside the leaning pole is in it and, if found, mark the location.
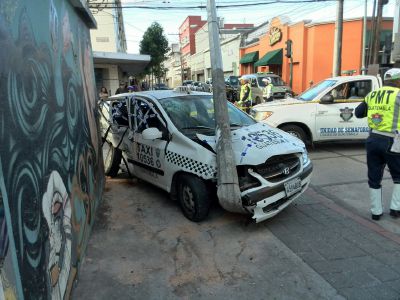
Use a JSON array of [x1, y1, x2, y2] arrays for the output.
[[178, 174, 211, 222]]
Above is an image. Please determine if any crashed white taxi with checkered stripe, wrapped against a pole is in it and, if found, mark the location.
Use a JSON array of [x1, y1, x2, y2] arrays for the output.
[[101, 89, 312, 222]]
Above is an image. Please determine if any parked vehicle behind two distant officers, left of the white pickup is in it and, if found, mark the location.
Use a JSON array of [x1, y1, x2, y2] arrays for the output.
[[241, 73, 293, 104]]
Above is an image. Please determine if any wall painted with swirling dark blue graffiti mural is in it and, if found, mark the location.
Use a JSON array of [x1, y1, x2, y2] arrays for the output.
[[0, 0, 104, 299]]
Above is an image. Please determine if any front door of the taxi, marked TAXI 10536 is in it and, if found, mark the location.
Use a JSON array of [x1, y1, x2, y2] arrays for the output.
[[128, 97, 168, 188]]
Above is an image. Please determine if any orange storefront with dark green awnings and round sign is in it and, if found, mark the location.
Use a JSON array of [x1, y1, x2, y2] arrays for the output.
[[240, 18, 393, 93]]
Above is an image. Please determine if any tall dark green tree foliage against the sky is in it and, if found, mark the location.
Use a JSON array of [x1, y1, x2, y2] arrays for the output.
[[140, 22, 170, 78]]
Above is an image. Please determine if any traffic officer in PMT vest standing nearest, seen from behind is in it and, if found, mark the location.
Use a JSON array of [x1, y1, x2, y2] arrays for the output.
[[355, 69, 400, 220]]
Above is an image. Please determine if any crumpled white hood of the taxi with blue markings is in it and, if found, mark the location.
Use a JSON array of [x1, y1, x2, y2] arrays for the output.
[[197, 123, 305, 165]]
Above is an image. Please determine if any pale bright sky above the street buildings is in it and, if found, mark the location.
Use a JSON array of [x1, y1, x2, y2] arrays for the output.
[[115, 0, 396, 53]]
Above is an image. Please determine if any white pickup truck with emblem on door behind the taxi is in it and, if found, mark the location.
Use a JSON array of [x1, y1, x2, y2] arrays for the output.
[[250, 75, 382, 143]]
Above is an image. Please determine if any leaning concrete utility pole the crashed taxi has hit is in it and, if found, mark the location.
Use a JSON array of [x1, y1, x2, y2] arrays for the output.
[[207, 0, 243, 212]]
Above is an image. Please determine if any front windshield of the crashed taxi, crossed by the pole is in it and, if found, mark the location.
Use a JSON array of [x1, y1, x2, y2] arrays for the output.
[[159, 95, 256, 135]]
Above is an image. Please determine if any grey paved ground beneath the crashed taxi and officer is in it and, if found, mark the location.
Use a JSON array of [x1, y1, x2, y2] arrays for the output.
[[74, 143, 400, 299]]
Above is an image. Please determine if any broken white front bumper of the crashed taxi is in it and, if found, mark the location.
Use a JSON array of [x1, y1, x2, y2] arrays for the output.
[[242, 162, 313, 223]]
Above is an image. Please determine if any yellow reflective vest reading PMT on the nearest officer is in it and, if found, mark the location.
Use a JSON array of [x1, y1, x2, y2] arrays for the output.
[[365, 86, 400, 133]]
